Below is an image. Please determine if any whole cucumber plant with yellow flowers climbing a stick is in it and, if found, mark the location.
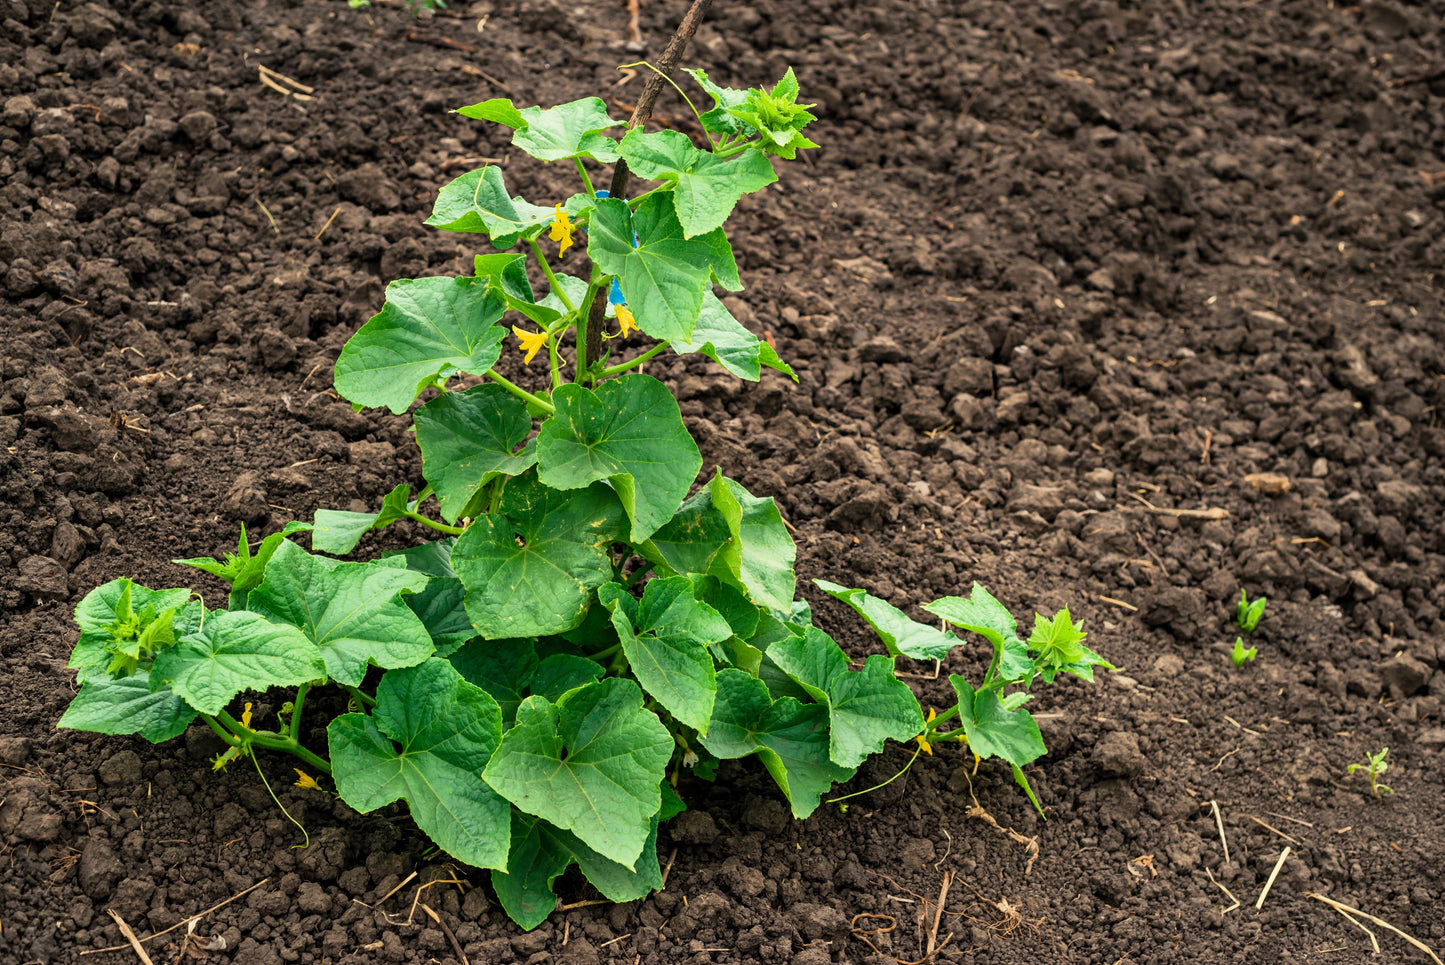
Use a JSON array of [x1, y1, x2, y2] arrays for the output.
[[59, 71, 1108, 927]]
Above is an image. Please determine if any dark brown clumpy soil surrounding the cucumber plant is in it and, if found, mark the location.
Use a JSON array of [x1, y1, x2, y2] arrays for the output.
[[0, 0, 1445, 965]]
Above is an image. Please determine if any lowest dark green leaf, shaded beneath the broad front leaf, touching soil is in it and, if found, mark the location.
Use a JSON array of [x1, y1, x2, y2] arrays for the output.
[[491, 812, 662, 929]]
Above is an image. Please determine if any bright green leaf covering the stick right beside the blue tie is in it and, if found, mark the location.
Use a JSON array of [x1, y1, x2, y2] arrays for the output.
[[587, 194, 741, 339]]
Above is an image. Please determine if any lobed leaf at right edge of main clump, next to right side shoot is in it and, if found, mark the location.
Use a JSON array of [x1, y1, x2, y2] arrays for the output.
[[767, 627, 923, 767]]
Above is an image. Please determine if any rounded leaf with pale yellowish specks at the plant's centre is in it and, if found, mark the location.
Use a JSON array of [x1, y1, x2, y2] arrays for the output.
[[452, 471, 624, 640]]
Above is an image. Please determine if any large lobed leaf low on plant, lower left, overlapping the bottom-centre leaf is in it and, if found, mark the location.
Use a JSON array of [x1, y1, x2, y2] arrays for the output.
[[327, 660, 512, 868]]
